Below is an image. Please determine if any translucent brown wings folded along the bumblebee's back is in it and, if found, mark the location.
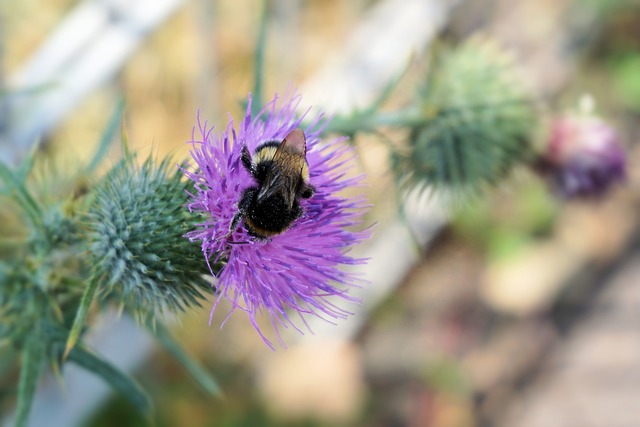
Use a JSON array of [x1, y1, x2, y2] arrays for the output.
[[258, 129, 307, 207]]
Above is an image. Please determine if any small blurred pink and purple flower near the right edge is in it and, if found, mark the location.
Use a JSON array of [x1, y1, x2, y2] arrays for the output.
[[541, 115, 626, 198]]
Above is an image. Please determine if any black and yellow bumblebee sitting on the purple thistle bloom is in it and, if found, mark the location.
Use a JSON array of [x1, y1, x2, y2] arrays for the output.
[[229, 129, 315, 239]]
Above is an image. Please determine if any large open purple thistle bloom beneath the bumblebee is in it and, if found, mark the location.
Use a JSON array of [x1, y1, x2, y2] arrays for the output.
[[185, 93, 369, 348]]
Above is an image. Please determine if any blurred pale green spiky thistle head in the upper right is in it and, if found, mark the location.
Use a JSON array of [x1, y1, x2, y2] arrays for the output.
[[402, 39, 536, 194]]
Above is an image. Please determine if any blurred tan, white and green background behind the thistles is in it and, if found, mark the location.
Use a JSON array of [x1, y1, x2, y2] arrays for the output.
[[0, 0, 640, 427]]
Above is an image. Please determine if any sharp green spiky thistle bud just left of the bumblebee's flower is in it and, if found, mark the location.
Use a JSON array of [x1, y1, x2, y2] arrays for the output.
[[88, 155, 211, 314]]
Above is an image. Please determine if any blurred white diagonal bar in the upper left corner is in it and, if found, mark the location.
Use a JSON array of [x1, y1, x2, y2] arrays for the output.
[[0, 0, 183, 164]]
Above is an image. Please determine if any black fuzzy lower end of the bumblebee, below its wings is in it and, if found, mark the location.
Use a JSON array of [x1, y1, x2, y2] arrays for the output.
[[245, 194, 301, 237]]
